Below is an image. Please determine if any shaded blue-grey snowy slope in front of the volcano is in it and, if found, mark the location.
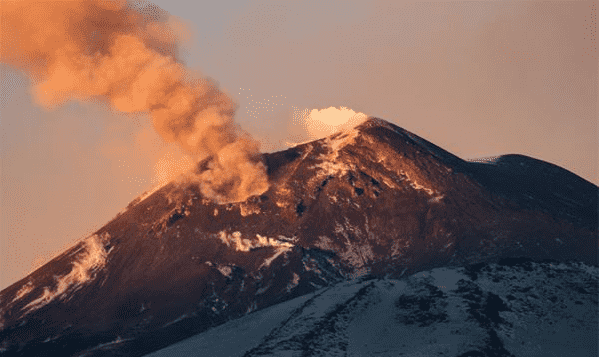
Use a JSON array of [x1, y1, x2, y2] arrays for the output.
[[148, 259, 599, 357]]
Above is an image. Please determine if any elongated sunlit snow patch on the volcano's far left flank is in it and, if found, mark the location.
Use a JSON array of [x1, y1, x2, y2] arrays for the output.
[[24, 234, 109, 313]]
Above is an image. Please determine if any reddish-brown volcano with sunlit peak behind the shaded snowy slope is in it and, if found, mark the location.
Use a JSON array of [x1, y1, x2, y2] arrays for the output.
[[0, 118, 599, 356]]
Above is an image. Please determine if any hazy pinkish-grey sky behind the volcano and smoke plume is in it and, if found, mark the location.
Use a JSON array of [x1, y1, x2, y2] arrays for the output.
[[0, 0, 599, 289]]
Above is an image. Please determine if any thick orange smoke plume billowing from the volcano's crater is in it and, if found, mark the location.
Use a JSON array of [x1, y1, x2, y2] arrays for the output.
[[0, 0, 268, 203]]
